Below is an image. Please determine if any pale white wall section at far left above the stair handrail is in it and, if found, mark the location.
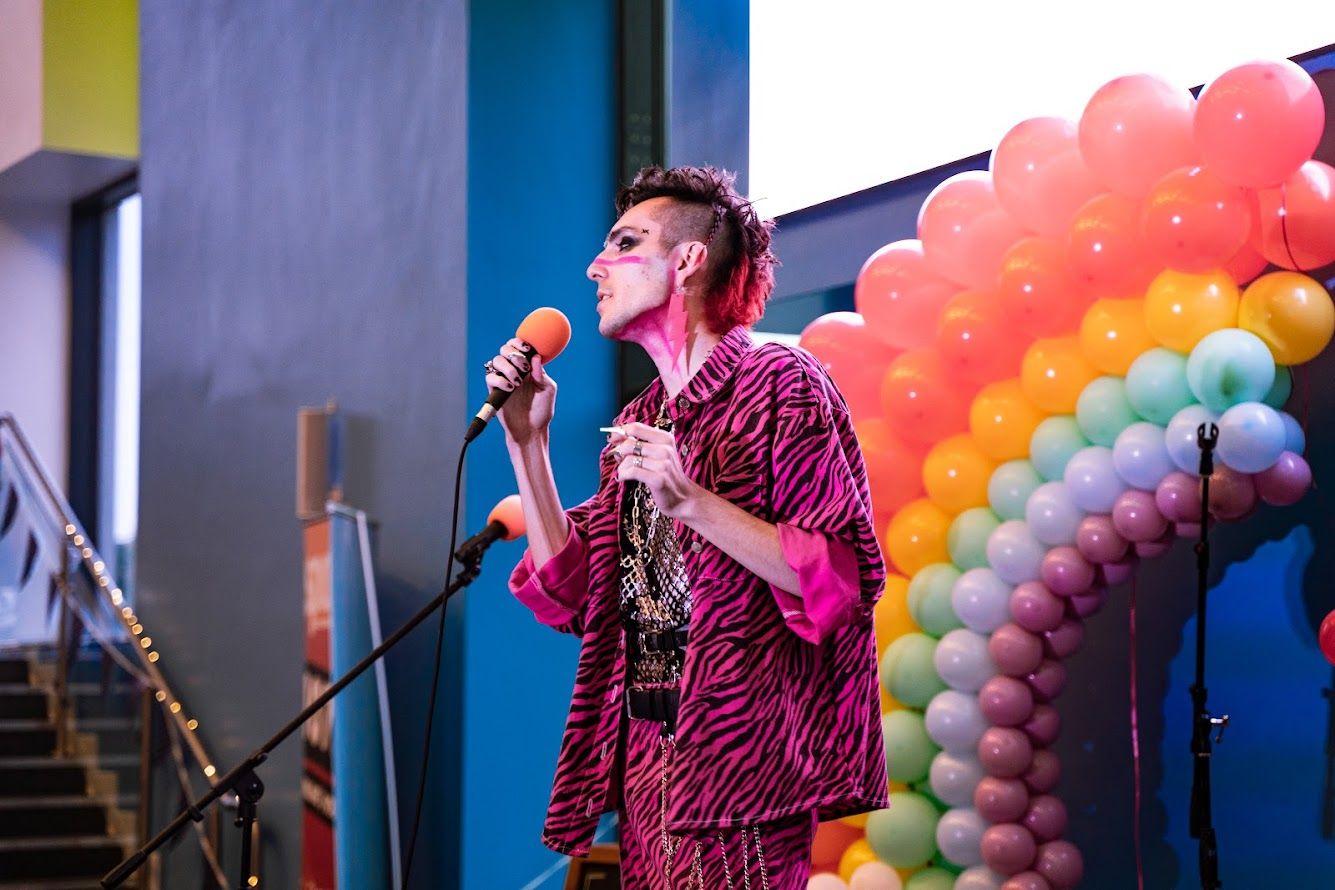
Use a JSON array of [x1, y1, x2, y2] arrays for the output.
[[0, 201, 69, 486]]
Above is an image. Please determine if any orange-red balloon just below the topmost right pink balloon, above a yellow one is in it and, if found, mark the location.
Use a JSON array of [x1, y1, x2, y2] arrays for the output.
[[1140, 167, 1252, 272]]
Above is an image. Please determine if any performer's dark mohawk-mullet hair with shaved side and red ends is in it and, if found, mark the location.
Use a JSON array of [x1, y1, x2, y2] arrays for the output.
[[617, 167, 778, 334]]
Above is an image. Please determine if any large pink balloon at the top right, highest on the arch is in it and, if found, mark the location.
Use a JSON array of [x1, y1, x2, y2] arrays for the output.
[[1195, 59, 1326, 188]]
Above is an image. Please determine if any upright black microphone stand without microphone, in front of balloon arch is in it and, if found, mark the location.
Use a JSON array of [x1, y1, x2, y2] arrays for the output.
[[1189, 423, 1228, 890]]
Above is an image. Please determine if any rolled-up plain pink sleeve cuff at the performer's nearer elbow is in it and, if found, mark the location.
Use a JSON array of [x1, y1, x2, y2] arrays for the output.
[[770, 523, 861, 643]]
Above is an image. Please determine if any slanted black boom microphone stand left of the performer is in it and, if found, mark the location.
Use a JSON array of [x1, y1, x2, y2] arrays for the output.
[[101, 522, 505, 890]]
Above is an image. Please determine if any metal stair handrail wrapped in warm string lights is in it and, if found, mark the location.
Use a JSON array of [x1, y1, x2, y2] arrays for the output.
[[0, 412, 233, 887]]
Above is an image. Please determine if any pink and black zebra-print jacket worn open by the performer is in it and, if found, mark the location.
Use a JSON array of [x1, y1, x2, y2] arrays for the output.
[[510, 327, 888, 855]]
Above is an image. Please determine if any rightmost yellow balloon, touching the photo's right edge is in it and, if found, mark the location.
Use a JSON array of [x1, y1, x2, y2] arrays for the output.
[[1238, 272, 1335, 364]]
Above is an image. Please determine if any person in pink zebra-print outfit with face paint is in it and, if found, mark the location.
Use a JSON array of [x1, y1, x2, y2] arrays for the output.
[[486, 167, 888, 889]]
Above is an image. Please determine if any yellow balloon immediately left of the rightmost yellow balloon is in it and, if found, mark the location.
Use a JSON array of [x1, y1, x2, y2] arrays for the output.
[[1145, 270, 1238, 352]]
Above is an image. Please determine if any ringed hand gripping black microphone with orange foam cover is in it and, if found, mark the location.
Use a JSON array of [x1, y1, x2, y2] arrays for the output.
[[463, 307, 570, 442]]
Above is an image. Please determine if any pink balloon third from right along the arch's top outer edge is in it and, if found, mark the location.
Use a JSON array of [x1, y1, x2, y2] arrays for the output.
[[991, 117, 1103, 236]]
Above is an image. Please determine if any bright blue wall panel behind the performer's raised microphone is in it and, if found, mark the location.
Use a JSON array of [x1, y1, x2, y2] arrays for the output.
[[461, 0, 617, 887]]
